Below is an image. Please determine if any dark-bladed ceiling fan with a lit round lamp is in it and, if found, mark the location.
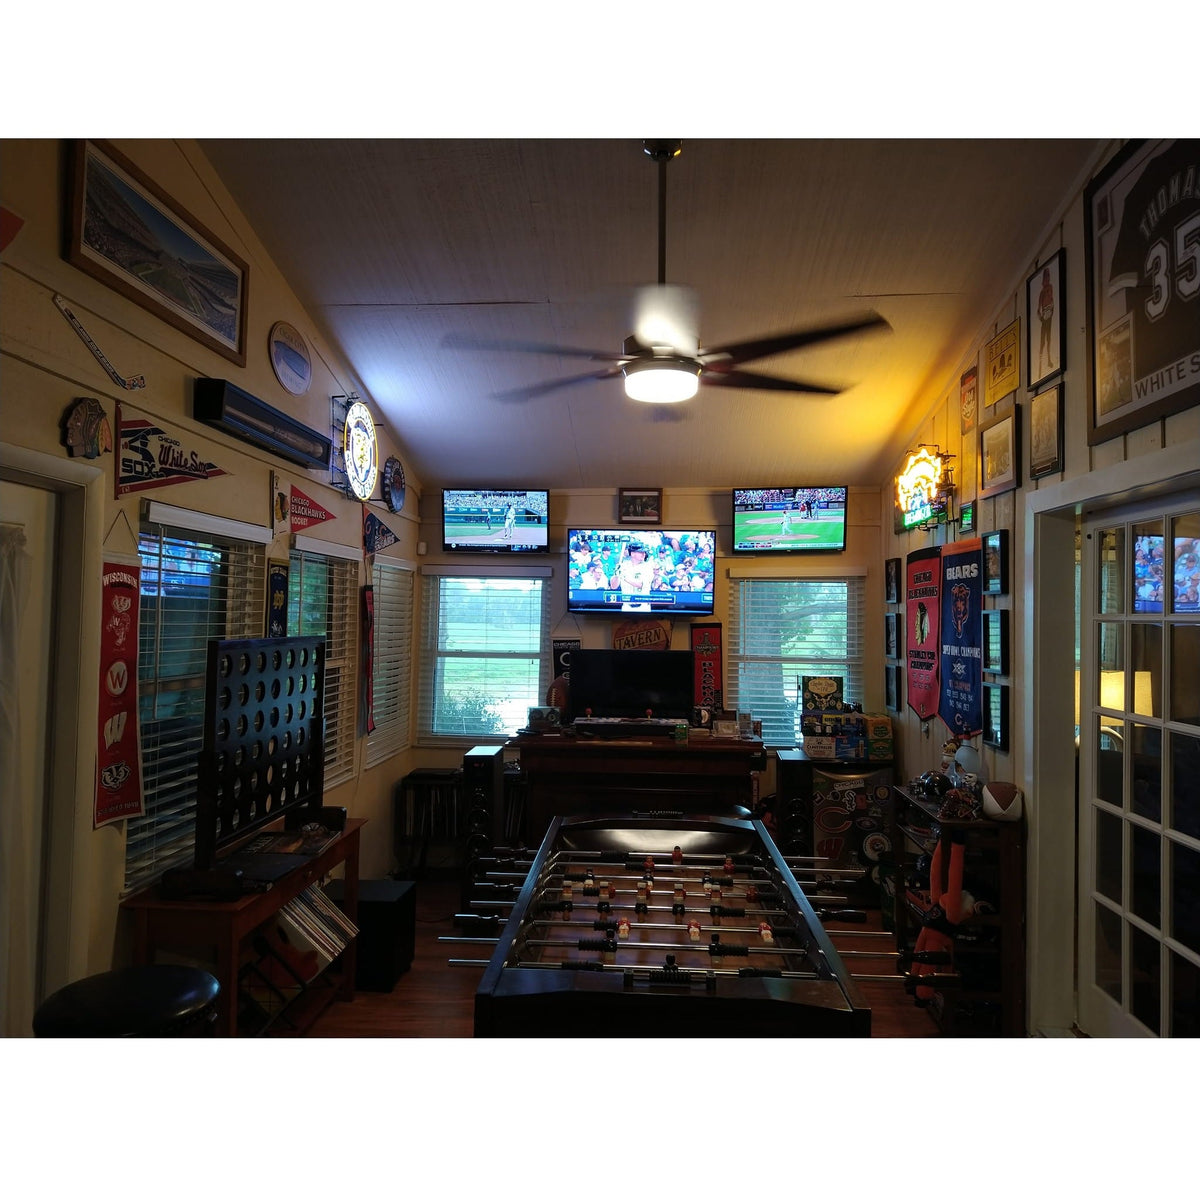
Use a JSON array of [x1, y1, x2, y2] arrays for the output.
[[442, 140, 888, 404]]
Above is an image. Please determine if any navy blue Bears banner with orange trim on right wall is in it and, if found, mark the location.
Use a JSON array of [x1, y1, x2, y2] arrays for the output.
[[938, 538, 983, 738]]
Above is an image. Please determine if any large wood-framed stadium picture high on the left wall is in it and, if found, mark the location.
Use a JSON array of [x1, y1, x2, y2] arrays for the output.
[[66, 142, 248, 366]]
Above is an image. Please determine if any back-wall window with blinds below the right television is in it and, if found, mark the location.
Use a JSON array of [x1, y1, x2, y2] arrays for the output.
[[727, 577, 864, 745]]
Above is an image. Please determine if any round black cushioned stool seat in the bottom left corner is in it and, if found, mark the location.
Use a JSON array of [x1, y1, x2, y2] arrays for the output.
[[34, 964, 221, 1038]]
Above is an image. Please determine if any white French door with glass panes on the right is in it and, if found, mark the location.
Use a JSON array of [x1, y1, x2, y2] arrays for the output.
[[1078, 492, 1200, 1037]]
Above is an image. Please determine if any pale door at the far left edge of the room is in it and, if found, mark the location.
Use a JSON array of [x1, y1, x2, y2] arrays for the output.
[[0, 480, 59, 1037]]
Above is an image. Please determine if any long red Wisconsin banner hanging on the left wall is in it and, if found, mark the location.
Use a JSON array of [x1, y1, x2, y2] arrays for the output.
[[91, 559, 144, 829]]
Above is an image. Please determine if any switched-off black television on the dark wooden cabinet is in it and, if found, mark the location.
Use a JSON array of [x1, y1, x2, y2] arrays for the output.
[[569, 649, 696, 720]]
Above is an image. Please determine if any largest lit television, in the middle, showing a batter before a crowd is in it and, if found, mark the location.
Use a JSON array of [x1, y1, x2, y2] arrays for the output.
[[566, 529, 716, 619]]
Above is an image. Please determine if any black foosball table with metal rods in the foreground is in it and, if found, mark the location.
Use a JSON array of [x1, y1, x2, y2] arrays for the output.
[[460, 814, 871, 1037]]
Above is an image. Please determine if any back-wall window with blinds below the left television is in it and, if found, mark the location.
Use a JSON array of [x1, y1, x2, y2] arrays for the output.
[[419, 569, 550, 742]]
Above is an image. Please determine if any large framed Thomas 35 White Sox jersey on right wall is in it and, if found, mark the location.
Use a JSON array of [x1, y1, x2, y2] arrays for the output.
[[1084, 139, 1200, 445]]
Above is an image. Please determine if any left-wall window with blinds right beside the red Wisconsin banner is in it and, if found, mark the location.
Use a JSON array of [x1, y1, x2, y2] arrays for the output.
[[125, 524, 266, 890]]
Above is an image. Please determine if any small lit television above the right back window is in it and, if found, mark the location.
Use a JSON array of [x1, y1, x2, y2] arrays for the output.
[[733, 487, 846, 554]]
